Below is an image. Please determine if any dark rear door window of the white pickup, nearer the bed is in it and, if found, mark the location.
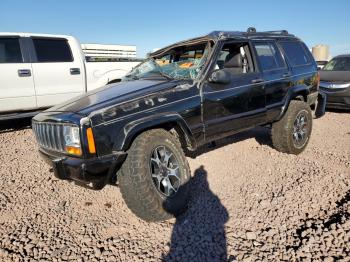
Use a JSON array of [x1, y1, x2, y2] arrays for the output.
[[33, 38, 73, 62]]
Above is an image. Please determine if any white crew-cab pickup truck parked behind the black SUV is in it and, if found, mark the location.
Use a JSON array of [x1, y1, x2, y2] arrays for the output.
[[0, 32, 139, 120]]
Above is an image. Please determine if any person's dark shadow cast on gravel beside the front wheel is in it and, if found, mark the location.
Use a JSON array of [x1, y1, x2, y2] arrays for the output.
[[163, 166, 229, 261]]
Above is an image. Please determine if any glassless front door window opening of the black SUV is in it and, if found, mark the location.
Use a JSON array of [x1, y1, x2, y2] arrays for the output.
[[214, 42, 254, 75]]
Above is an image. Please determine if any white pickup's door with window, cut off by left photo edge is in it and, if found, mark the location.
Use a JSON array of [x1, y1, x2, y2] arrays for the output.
[[0, 36, 36, 113]]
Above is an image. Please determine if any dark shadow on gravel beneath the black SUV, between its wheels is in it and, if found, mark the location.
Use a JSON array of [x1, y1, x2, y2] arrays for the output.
[[186, 127, 273, 158]]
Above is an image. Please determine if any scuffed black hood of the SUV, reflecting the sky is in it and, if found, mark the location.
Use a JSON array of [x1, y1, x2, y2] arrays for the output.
[[47, 79, 178, 116]]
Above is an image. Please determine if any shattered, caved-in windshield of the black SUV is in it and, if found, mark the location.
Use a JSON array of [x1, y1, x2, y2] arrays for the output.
[[123, 43, 208, 81]]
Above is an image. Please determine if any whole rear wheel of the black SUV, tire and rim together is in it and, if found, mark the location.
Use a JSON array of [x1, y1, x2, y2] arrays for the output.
[[271, 100, 312, 155]]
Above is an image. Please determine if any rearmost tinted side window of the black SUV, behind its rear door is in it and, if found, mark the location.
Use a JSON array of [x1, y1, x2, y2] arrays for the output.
[[280, 41, 311, 66]]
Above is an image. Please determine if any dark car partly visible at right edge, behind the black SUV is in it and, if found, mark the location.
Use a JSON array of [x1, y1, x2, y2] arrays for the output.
[[319, 54, 350, 109]]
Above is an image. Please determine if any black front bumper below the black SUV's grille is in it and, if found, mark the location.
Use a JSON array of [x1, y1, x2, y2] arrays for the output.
[[39, 148, 126, 190]]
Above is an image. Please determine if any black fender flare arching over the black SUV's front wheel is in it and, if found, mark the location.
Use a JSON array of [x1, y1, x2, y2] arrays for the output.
[[121, 113, 197, 151]]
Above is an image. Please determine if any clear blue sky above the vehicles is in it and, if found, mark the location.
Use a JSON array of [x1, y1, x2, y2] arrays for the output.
[[0, 0, 350, 57]]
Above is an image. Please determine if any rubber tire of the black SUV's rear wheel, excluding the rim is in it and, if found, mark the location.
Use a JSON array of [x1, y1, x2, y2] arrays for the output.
[[271, 100, 312, 155]]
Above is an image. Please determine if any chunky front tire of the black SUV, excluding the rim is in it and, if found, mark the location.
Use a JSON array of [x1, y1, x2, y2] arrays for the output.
[[118, 129, 191, 222]]
